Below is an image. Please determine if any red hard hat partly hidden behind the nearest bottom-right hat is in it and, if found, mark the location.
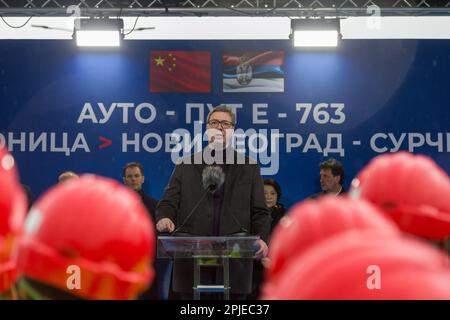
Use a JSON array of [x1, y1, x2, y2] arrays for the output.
[[267, 196, 398, 280]]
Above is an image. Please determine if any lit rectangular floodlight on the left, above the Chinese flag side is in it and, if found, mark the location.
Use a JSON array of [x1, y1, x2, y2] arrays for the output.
[[74, 18, 123, 47]]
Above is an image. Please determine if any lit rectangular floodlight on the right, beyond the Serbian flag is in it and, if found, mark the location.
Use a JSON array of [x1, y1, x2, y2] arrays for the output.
[[291, 18, 340, 47]]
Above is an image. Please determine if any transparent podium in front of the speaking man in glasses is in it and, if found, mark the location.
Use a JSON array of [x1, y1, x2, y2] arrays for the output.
[[157, 236, 260, 300]]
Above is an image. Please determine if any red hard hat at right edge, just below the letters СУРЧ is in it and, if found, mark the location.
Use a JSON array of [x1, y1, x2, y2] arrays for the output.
[[350, 152, 450, 240]]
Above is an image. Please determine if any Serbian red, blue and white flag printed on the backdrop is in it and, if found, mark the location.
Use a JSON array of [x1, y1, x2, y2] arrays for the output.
[[222, 51, 284, 92]]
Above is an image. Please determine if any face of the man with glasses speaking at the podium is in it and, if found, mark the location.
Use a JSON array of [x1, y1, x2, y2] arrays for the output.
[[206, 111, 234, 148]]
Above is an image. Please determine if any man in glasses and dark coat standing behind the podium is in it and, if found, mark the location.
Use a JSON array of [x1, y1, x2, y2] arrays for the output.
[[156, 105, 270, 298]]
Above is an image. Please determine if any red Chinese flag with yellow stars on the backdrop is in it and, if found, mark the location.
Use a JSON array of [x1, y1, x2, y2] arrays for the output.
[[150, 51, 211, 93]]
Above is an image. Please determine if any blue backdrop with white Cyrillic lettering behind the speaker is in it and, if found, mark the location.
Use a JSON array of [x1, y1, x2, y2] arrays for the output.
[[0, 40, 450, 205]]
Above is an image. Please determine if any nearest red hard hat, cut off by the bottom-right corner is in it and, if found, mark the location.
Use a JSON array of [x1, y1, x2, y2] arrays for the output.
[[263, 231, 450, 300]]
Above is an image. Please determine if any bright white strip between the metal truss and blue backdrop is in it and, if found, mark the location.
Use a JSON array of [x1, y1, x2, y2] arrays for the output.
[[0, 16, 450, 40]]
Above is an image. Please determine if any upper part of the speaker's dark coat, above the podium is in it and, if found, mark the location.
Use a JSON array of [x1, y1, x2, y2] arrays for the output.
[[156, 151, 270, 242]]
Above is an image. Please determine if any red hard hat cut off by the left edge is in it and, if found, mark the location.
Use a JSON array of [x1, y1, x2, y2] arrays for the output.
[[0, 148, 27, 293]]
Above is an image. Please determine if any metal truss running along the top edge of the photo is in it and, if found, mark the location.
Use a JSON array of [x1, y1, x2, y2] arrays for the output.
[[0, 0, 450, 17]]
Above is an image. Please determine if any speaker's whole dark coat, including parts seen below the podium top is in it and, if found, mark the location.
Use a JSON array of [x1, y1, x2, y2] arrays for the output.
[[156, 152, 271, 293]]
